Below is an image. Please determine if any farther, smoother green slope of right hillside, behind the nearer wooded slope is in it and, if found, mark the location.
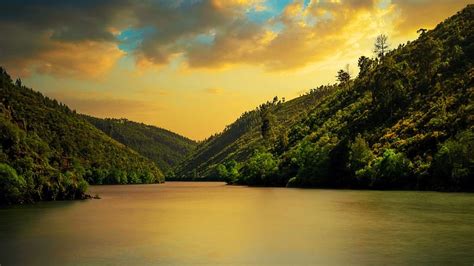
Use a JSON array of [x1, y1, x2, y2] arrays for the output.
[[175, 86, 332, 179]]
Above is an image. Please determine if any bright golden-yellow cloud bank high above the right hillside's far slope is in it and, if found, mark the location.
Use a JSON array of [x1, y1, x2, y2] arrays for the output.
[[187, 0, 377, 70]]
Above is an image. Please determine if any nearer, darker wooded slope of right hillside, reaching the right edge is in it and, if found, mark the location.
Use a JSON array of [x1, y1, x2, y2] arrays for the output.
[[268, 5, 474, 190]]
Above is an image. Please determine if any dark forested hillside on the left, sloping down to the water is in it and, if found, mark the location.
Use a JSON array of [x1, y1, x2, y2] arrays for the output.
[[0, 68, 164, 204]]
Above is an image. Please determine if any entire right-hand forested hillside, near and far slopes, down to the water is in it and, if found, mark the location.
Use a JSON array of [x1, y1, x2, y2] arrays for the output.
[[178, 5, 474, 191]]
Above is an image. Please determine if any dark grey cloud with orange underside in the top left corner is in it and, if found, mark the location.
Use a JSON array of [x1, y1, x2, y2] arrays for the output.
[[0, 0, 130, 75]]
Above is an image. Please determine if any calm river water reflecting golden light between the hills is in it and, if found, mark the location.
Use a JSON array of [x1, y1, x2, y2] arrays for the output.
[[0, 182, 474, 266]]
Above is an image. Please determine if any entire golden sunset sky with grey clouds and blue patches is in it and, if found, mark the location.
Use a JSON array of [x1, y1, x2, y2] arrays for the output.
[[0, 0, 472, 140]]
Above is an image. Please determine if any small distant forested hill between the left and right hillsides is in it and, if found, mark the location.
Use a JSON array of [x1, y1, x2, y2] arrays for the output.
[[84, 115, 196, 173]]
